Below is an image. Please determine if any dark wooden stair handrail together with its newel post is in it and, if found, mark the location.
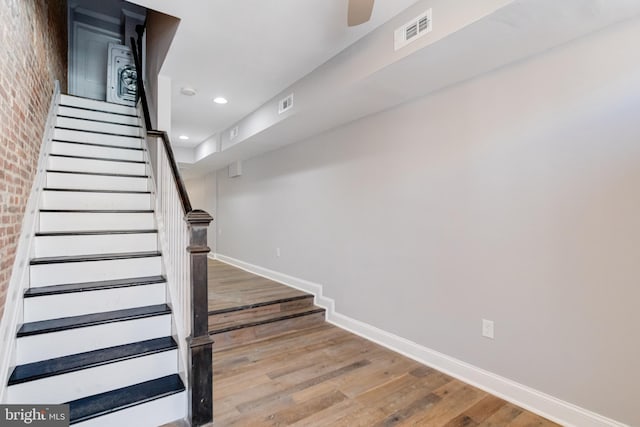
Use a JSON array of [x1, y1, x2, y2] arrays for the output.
[[131, 31, 213, 427]]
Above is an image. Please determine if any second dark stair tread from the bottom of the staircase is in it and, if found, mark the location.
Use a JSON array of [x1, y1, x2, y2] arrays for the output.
[[9, 337, 178, 386]]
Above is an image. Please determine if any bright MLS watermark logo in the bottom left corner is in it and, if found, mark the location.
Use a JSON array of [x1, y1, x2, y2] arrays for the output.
[[0, 405, 69, 427]]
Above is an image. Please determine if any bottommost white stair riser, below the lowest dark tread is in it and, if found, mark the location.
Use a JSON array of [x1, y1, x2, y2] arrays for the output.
[[73, 391, 187, 427]]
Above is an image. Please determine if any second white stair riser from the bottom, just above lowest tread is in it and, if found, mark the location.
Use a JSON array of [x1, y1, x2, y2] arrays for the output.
[[7, 350, 178, 404]]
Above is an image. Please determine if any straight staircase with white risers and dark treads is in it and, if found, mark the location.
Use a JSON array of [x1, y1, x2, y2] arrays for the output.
[[6, 95, 187, 427]]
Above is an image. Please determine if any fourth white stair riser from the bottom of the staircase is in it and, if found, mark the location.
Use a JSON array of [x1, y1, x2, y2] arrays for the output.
[[24, 283, 167, 322]]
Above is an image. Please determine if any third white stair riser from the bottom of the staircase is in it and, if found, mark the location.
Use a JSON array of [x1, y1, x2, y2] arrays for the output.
[[16, 314, 171, 365]]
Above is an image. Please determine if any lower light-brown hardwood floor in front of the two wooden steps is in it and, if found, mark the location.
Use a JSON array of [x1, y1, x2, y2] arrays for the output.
[[213, 323, 557, 427]]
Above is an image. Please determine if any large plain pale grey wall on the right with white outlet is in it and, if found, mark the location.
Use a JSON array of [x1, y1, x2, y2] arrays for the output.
[[214, 20, 640, 425]]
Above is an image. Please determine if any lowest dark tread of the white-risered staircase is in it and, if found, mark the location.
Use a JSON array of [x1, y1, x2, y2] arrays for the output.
[[67, 374, 185, 424]]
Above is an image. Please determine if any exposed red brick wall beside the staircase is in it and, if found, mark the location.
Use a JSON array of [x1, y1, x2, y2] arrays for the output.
[[0, 0, 67, 320]]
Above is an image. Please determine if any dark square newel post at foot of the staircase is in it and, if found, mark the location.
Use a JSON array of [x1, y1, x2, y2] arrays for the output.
[[186, 209, 213, 427]]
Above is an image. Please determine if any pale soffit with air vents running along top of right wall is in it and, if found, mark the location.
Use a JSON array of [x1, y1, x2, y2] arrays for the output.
[[169, 0, 640, 179]]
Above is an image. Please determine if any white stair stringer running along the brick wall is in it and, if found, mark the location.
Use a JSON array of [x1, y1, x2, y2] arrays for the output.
[[0, 80, 60, 403]]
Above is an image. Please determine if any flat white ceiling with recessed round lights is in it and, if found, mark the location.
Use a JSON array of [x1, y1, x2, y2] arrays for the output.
[[130, 0, 416, 147]]
